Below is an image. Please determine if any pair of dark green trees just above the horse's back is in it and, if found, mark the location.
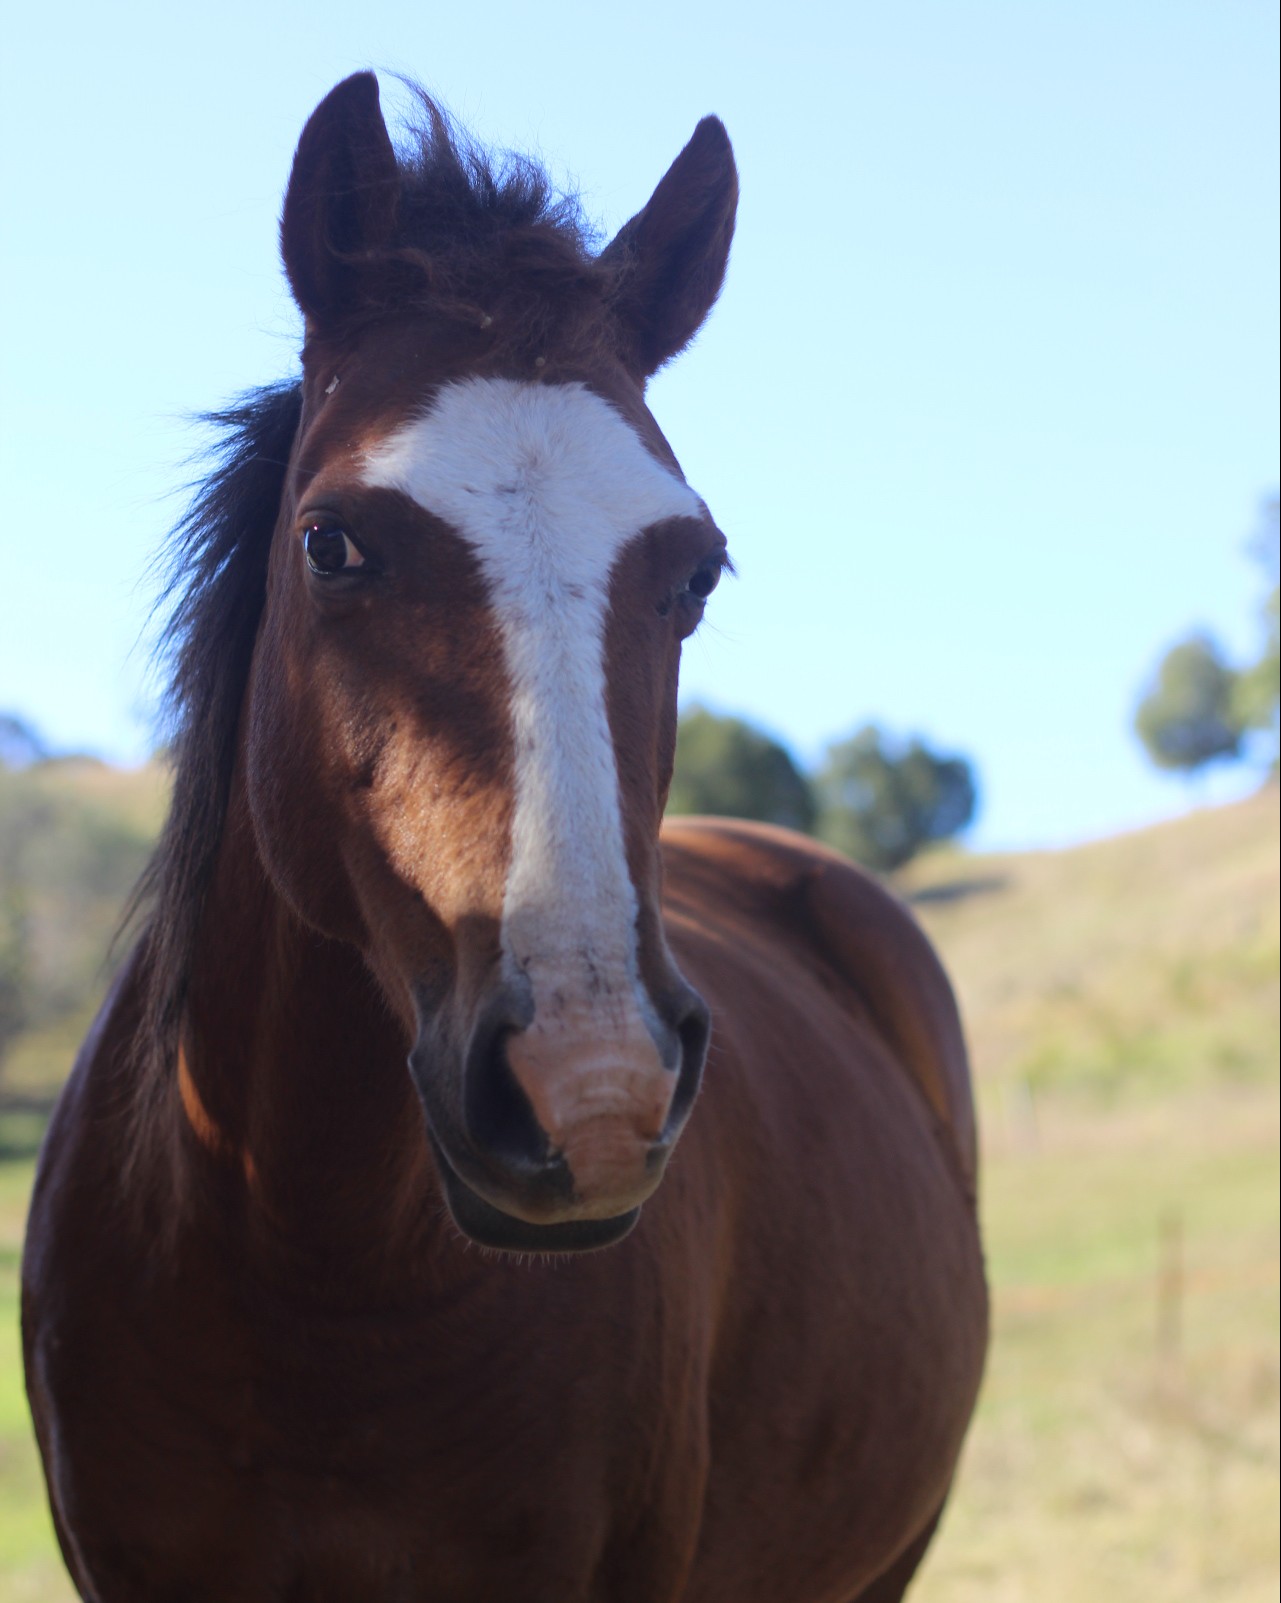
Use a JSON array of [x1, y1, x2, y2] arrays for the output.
[[667, 707, 978, 870]]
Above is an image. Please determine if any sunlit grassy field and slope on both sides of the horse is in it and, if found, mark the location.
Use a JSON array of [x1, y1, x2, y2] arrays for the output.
[[0, 789, 1281, 1603]]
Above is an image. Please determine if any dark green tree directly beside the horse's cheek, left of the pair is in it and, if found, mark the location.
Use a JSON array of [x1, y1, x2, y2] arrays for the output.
[[667, 707, 814, 830]]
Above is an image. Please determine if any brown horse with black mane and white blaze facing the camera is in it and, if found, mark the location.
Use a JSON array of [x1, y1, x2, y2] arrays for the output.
[[24, 74, 986, 1603]]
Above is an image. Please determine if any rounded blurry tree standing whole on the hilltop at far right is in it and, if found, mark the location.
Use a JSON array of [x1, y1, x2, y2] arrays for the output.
[[1134, 635, 1243, 773]]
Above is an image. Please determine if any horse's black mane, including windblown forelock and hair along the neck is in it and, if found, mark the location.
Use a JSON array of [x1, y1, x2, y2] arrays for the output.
[[130, 91, 608, 1064]]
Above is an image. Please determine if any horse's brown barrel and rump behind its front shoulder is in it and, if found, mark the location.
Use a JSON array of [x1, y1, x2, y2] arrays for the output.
[[654, 819, 988, 1603]]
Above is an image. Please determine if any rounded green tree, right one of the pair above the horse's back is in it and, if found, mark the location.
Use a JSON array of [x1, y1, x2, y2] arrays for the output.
[[814, 725, 978, 870]]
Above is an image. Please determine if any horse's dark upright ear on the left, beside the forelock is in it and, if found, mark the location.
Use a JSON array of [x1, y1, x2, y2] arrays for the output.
[[281, 72, 401, 324]]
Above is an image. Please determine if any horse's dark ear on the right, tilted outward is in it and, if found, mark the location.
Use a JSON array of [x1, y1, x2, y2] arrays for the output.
[[600, 117, 739, 378]]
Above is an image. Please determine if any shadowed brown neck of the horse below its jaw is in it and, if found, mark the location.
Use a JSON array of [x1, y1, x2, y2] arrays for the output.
[[178, 763, 447, 1284]]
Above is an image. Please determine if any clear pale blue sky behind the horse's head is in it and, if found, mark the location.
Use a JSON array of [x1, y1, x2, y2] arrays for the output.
[[0, 0, 1278, 846]]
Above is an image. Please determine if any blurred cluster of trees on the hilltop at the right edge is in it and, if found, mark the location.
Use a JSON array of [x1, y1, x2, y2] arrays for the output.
[[1134, 497, 1281, 774]]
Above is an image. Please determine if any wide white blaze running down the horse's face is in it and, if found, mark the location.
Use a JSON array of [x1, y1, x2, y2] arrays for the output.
[[362, 378, 704, 1028]]
